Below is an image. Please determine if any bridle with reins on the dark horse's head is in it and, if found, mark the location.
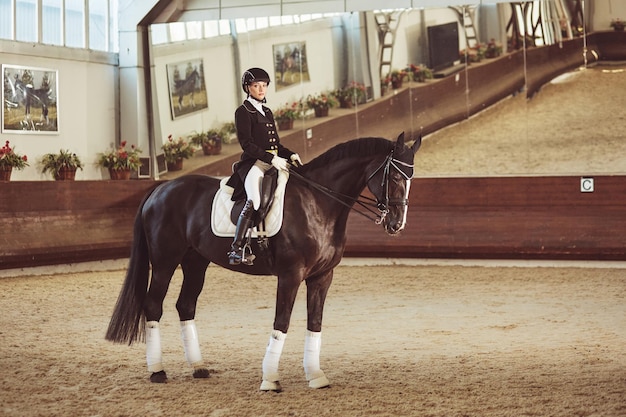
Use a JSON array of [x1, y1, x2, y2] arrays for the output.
[[289, 149, 413, 224]]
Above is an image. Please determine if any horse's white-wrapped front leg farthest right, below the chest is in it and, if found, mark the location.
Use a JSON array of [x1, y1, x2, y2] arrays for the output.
[[302, 269, 333, 388]]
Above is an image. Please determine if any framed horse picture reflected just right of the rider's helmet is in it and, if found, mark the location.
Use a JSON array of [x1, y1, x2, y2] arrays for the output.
[[272, 42, 311, 90]]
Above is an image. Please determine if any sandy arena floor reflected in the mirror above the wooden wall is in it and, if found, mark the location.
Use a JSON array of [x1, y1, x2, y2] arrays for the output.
[[415, 65, 626, 177]]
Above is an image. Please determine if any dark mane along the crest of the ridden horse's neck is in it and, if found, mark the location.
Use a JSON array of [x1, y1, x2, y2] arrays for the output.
[[294, 137, 394, 173]]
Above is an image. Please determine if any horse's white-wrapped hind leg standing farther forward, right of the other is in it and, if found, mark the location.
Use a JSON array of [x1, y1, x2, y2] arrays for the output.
[[176, 252, 209, 378]]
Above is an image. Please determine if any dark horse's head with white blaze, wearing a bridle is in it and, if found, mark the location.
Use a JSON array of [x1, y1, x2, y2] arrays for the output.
[[367, 133, 422, 235]]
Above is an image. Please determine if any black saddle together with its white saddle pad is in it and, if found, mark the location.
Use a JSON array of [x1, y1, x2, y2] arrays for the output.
[[211, 167, 289, 238]]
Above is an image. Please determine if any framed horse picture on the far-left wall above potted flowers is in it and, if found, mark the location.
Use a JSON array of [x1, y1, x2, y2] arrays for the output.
[[2, 64, 59, 134]]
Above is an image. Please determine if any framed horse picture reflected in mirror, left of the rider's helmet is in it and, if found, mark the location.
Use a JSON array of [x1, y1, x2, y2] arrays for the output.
[[166, 58, 209, 120]]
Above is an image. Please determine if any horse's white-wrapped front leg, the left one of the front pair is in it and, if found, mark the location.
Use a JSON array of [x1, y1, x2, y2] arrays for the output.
[[261, 276, 301, 392]]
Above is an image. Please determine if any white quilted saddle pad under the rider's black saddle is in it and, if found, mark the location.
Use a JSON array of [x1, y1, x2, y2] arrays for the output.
[[211, 171, 289, 237]]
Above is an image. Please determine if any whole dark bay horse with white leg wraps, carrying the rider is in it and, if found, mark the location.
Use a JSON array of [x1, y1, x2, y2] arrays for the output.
[[106, 134, 421, 391]]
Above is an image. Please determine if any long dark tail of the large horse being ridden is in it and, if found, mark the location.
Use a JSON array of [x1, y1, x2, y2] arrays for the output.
[[105, 193, 151, 345]]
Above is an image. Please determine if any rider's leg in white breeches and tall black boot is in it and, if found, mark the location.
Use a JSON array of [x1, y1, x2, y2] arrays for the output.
[[228, 164, 265, 265]]
